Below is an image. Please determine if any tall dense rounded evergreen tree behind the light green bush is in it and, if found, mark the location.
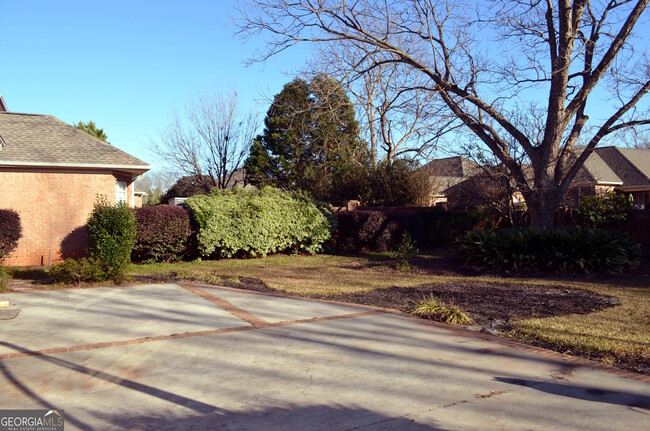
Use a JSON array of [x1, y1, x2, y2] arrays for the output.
[[244, 75, 367, 202]]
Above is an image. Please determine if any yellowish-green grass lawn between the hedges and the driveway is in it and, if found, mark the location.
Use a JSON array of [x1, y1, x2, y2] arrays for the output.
[[3, 251, 650, 374]]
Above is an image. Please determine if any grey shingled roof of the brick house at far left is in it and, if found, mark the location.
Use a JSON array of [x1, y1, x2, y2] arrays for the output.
[[0, 112, 151, 175]]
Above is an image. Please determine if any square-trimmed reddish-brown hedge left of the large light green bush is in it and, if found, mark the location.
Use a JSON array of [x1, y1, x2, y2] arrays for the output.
[[131, 205, 192, 262]]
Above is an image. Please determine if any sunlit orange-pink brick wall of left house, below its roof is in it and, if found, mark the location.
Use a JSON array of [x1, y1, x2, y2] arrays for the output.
[[0, 169, 133, 266]]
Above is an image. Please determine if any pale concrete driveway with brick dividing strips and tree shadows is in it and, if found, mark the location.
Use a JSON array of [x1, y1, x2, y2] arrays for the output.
[[0, 284, 650, 431]]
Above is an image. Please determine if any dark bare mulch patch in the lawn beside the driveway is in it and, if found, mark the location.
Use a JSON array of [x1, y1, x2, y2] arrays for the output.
[[328, 282, 617, 322]]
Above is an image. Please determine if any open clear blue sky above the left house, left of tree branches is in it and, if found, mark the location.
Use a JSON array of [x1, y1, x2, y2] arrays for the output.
[[0, 0, 307, 167]]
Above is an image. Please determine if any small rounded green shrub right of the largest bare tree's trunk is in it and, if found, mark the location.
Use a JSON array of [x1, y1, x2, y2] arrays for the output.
[[578, 192, 634, 227]]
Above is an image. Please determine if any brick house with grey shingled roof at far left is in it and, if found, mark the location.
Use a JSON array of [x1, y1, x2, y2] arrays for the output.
[[0, 109, 150, 266]]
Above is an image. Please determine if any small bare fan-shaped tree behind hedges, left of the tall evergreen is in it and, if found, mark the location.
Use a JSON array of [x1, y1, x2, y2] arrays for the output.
[[153, 91, 258, 191]]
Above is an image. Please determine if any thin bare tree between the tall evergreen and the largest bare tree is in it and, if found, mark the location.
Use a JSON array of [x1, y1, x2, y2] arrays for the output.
[[309, 41, 458, 166]]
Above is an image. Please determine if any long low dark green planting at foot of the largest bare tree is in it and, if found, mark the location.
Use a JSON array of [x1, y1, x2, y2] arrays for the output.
[[458, 227, 641, 272]]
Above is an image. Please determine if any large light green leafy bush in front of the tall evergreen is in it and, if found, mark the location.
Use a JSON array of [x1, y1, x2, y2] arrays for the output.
[[186, 187, 331, 257]]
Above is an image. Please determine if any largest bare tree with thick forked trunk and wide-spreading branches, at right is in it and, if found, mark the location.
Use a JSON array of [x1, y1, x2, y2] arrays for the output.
[[239, 0, 650, 228]]
